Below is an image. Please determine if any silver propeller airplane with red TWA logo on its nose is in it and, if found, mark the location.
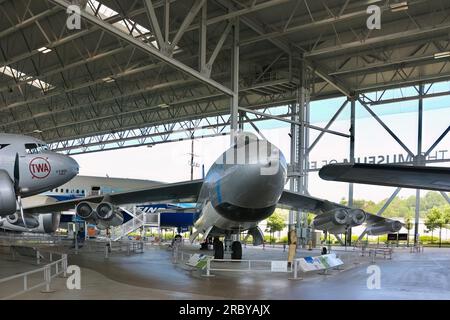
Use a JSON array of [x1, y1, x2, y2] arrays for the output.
[[0, 133, 79, 232]]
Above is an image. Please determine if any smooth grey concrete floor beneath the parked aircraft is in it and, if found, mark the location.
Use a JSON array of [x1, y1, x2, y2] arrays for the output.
[[0, 247, 450, 300]]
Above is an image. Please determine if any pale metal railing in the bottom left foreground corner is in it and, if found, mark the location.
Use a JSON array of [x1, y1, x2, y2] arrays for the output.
[[0, 253, 67, 300]]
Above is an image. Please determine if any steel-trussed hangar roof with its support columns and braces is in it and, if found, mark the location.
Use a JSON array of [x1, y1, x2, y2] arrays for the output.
[[0, 0, 450, 300]]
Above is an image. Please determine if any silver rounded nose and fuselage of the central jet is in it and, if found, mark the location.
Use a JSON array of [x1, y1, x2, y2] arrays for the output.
[[194, 136, 287, 235]]
